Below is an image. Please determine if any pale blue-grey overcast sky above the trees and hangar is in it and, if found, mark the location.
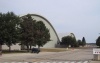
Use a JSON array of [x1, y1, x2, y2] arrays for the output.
[[0, 0, 100, 43]]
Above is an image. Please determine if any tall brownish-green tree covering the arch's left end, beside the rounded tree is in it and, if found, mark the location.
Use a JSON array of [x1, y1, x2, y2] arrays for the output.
[[20, 14, 36, 51]]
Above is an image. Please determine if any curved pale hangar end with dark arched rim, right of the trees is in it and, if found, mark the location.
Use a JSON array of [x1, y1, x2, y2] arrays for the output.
[[30, 14, 60, 48]]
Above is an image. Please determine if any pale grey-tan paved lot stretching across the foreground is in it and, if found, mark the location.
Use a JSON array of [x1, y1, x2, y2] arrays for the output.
[[0, 48, 99, 63]]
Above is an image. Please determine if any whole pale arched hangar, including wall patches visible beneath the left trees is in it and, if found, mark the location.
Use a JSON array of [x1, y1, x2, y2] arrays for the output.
[[2, 14, 60, 49]]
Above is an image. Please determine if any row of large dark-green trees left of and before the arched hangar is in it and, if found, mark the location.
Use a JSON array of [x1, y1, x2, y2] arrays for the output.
[[0, 12, 50, 51]]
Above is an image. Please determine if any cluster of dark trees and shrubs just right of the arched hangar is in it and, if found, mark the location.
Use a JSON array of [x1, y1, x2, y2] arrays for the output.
[[61, 33, 86, 47]]
